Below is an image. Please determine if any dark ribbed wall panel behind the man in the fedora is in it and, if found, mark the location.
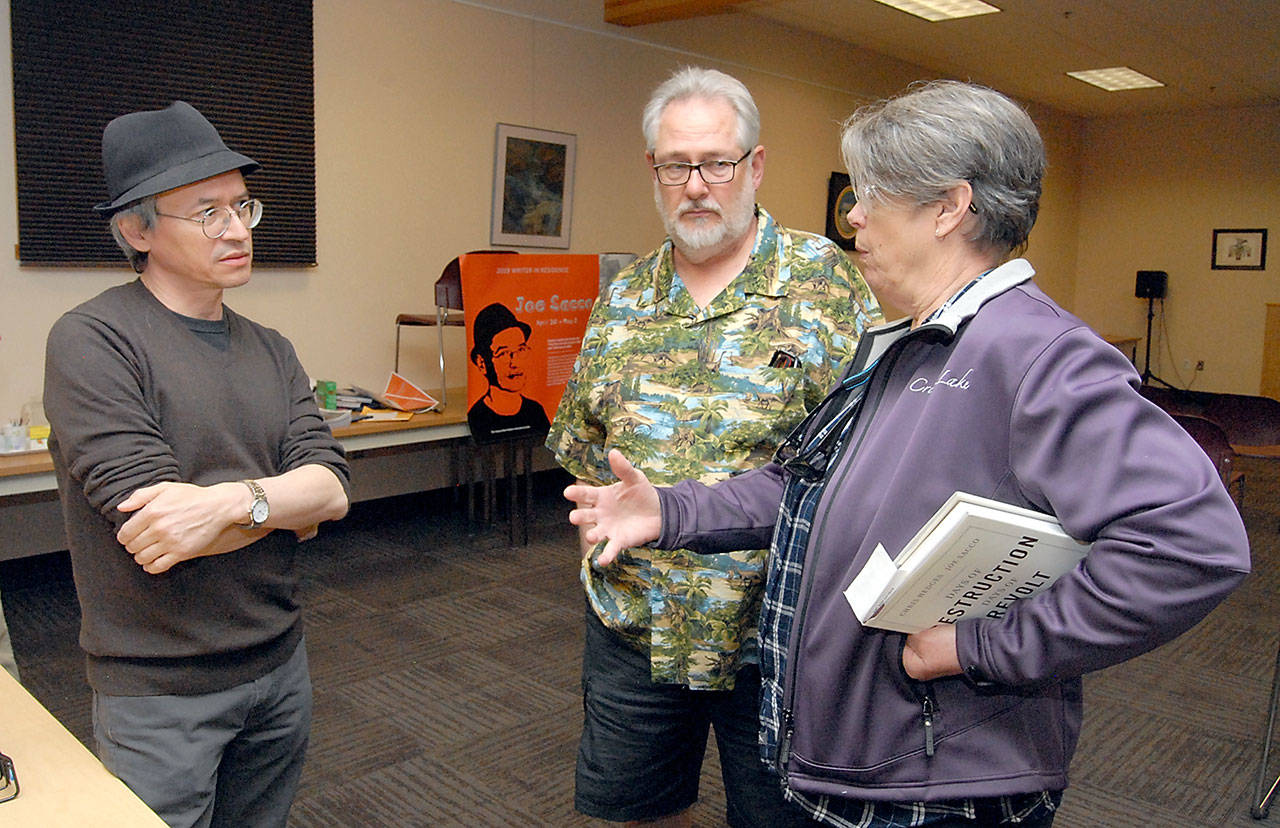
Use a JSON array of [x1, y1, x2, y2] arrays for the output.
[[10, 0, 316, 266]]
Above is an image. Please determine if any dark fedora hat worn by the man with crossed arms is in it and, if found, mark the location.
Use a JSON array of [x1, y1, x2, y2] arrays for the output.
[[93, 101, 259, 212]]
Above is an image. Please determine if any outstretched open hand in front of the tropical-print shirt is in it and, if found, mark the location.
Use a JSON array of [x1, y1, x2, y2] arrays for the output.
[[564, 449, 662, 567]]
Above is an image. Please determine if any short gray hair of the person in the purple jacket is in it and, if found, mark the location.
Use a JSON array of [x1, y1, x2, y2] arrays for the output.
[[840, 81, 1044, 255]]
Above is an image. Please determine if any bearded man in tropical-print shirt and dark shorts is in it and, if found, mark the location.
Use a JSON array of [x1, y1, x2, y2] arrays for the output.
[[547, 68, 879, 828]]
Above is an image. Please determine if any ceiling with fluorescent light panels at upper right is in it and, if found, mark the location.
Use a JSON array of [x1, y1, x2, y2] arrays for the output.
[[727, 0, 1280, 116]]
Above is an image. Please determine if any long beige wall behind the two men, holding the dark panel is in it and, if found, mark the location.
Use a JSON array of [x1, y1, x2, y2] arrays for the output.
[[0, 0, 1090, 420]]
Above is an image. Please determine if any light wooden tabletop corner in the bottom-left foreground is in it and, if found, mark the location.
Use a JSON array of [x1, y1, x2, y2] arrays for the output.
[[0, 669, 164, 828]]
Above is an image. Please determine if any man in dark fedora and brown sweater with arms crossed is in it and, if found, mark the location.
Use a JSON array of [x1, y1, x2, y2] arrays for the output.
[[44, 101, 349, 825]]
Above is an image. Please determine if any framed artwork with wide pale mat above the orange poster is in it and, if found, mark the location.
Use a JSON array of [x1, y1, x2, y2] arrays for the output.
[[489, 124, 577, 247]]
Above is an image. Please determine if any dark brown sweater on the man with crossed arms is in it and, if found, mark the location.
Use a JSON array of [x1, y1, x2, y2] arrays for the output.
[[44, 280, 349, 695]]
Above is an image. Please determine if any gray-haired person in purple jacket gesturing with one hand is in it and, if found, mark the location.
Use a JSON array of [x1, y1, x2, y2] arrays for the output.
[[566, 82, 1249, 828]]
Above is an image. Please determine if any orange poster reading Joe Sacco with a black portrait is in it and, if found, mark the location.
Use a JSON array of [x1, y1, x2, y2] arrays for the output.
[[458, 253, 599, 442]]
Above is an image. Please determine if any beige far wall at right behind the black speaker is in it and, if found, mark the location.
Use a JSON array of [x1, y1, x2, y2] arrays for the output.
[[1075, 106, 1280, 394]]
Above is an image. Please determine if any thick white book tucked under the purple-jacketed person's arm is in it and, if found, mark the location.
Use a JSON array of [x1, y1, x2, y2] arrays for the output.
[[845, 491, 1089, 632]]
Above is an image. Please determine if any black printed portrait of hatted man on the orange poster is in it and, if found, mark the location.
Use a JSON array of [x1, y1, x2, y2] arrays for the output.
[[467, 302, 550, 442]]
